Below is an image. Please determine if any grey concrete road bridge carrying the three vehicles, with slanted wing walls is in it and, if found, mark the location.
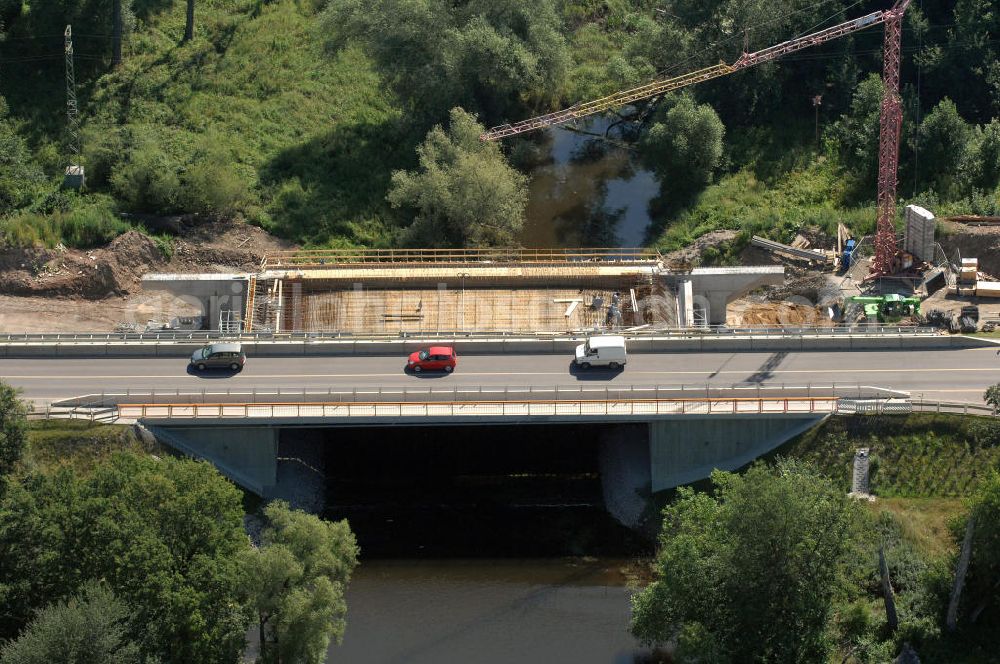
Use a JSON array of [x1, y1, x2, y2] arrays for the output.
[[0, 337, 1000, 495]]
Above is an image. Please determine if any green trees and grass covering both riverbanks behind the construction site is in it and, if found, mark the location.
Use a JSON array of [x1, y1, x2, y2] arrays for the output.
[[0, 0, 1000, 249]]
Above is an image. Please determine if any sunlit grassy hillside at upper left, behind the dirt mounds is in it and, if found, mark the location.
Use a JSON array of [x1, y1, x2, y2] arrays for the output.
[[0, 0, 406, 246]]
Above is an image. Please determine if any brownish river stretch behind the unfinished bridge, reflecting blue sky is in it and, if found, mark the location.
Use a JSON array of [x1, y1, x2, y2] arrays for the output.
[[521, 117, 659, 247]]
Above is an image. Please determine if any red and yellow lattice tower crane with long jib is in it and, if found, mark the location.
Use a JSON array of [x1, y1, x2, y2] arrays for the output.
[[479, 0, 911, 275]]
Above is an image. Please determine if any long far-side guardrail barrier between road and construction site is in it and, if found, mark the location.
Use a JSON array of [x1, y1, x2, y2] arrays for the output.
[[0, 325, 941, 344]]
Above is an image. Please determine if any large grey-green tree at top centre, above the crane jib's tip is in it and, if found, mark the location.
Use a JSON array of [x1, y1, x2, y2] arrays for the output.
[[325, 0, 569, 127]]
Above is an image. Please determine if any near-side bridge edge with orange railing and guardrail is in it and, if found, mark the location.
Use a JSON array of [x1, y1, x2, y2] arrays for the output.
[[35, 383, 908, 422]]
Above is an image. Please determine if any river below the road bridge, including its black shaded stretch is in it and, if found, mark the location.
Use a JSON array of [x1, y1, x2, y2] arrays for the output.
[[312, 425, 652, 664]]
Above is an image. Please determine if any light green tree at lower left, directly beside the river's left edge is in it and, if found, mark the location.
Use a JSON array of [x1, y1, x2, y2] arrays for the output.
[[246, 501, 358, 664]]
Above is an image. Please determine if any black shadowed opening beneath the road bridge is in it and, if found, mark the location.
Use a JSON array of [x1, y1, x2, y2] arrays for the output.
[[278, 424, 652, 558]]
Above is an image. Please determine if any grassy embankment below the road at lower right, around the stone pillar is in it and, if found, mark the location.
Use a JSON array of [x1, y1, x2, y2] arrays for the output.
[[777, 414, 1000, 664]]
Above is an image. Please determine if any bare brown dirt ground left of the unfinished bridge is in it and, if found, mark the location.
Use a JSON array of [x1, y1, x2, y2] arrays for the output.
[[0, 222, 294, 332]]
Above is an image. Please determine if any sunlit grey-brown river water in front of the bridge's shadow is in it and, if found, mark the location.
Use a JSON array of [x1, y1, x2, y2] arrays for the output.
[[327, 559, 649, 664]]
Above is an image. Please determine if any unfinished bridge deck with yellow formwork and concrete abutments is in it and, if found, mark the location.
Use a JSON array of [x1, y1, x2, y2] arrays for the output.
[[143, 249, 784, 336]]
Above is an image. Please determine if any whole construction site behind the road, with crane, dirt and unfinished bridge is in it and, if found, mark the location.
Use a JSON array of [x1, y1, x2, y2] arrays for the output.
[[0, 0, 1000, 336]]
